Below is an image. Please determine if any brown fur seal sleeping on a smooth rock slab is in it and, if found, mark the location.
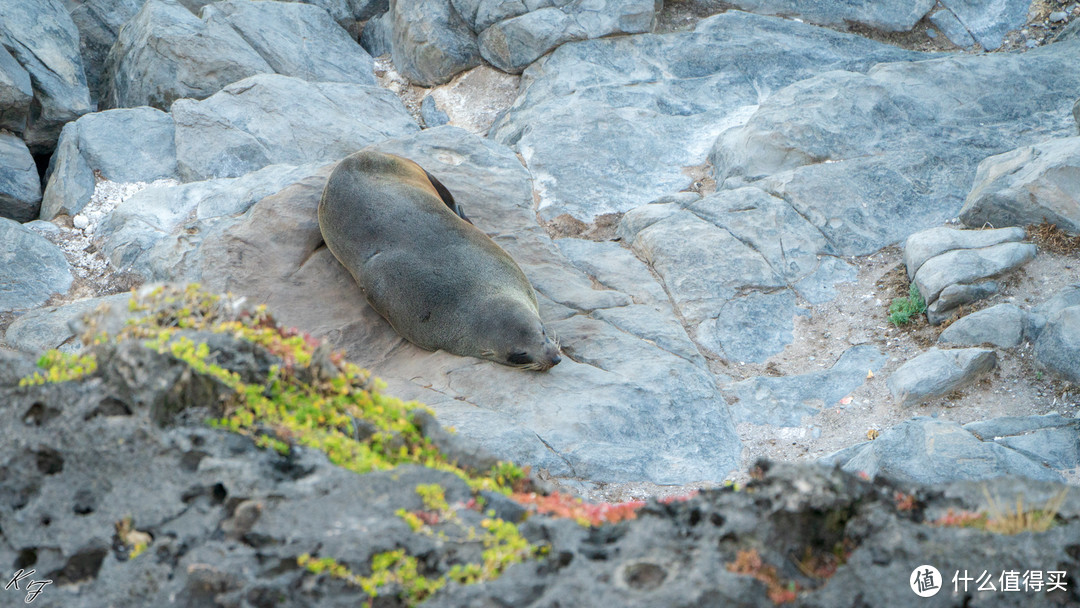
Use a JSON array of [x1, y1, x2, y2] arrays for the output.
[[319, 150, 561, 371]]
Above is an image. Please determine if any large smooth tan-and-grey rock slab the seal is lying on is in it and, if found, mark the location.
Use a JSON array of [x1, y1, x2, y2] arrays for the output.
[[95, 126, 741, 483]]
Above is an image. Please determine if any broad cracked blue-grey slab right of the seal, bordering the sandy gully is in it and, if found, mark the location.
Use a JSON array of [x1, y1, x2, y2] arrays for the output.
[[618, 188, 855, 362]]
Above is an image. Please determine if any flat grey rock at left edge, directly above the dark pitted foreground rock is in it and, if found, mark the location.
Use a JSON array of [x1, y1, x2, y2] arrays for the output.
[[3, 294, 131, 354]]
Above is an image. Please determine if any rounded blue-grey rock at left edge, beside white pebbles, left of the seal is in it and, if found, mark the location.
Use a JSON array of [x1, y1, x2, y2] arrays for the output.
[[0, 217, 72, 312]]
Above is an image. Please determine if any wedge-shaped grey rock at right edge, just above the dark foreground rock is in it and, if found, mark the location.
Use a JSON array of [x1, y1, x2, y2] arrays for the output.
[[963, 414, 1080, 471]]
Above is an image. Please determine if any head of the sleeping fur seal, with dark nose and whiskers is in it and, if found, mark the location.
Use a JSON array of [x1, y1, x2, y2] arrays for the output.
[[480, 307, 563, 371]]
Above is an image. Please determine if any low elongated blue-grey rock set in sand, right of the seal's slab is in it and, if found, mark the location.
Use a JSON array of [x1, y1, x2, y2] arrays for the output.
[[727, 344, 889, 427]]
